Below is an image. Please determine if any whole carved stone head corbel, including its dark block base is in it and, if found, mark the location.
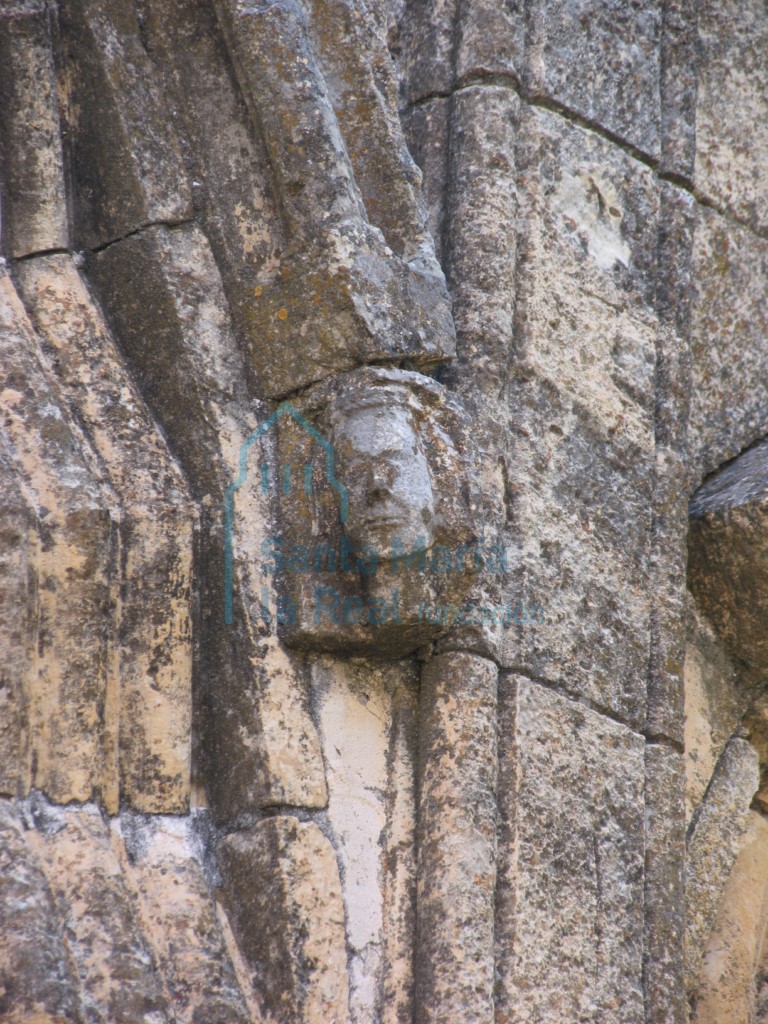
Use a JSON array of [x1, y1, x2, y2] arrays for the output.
[[268, 367, 476, 656]]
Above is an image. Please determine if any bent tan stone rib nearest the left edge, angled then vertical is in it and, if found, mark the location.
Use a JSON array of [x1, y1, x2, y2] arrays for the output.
[[0, 270, 118, 810]]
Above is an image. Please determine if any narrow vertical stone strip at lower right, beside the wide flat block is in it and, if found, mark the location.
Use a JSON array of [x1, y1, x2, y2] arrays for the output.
[[643, 743, 686, 1024]]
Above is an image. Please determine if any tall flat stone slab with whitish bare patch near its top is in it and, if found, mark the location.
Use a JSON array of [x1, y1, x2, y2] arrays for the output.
[[504, 112, 657, 723]]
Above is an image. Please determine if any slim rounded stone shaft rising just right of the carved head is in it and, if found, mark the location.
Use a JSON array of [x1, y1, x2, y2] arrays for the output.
[[428, 85, 519, 658]]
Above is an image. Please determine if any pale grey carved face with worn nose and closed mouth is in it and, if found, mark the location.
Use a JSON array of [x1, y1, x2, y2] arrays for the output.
[[333, 404, 434, 561]]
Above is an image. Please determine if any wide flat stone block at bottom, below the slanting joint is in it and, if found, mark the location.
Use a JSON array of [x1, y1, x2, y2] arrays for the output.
[[496, 673, 644, 1024]]
